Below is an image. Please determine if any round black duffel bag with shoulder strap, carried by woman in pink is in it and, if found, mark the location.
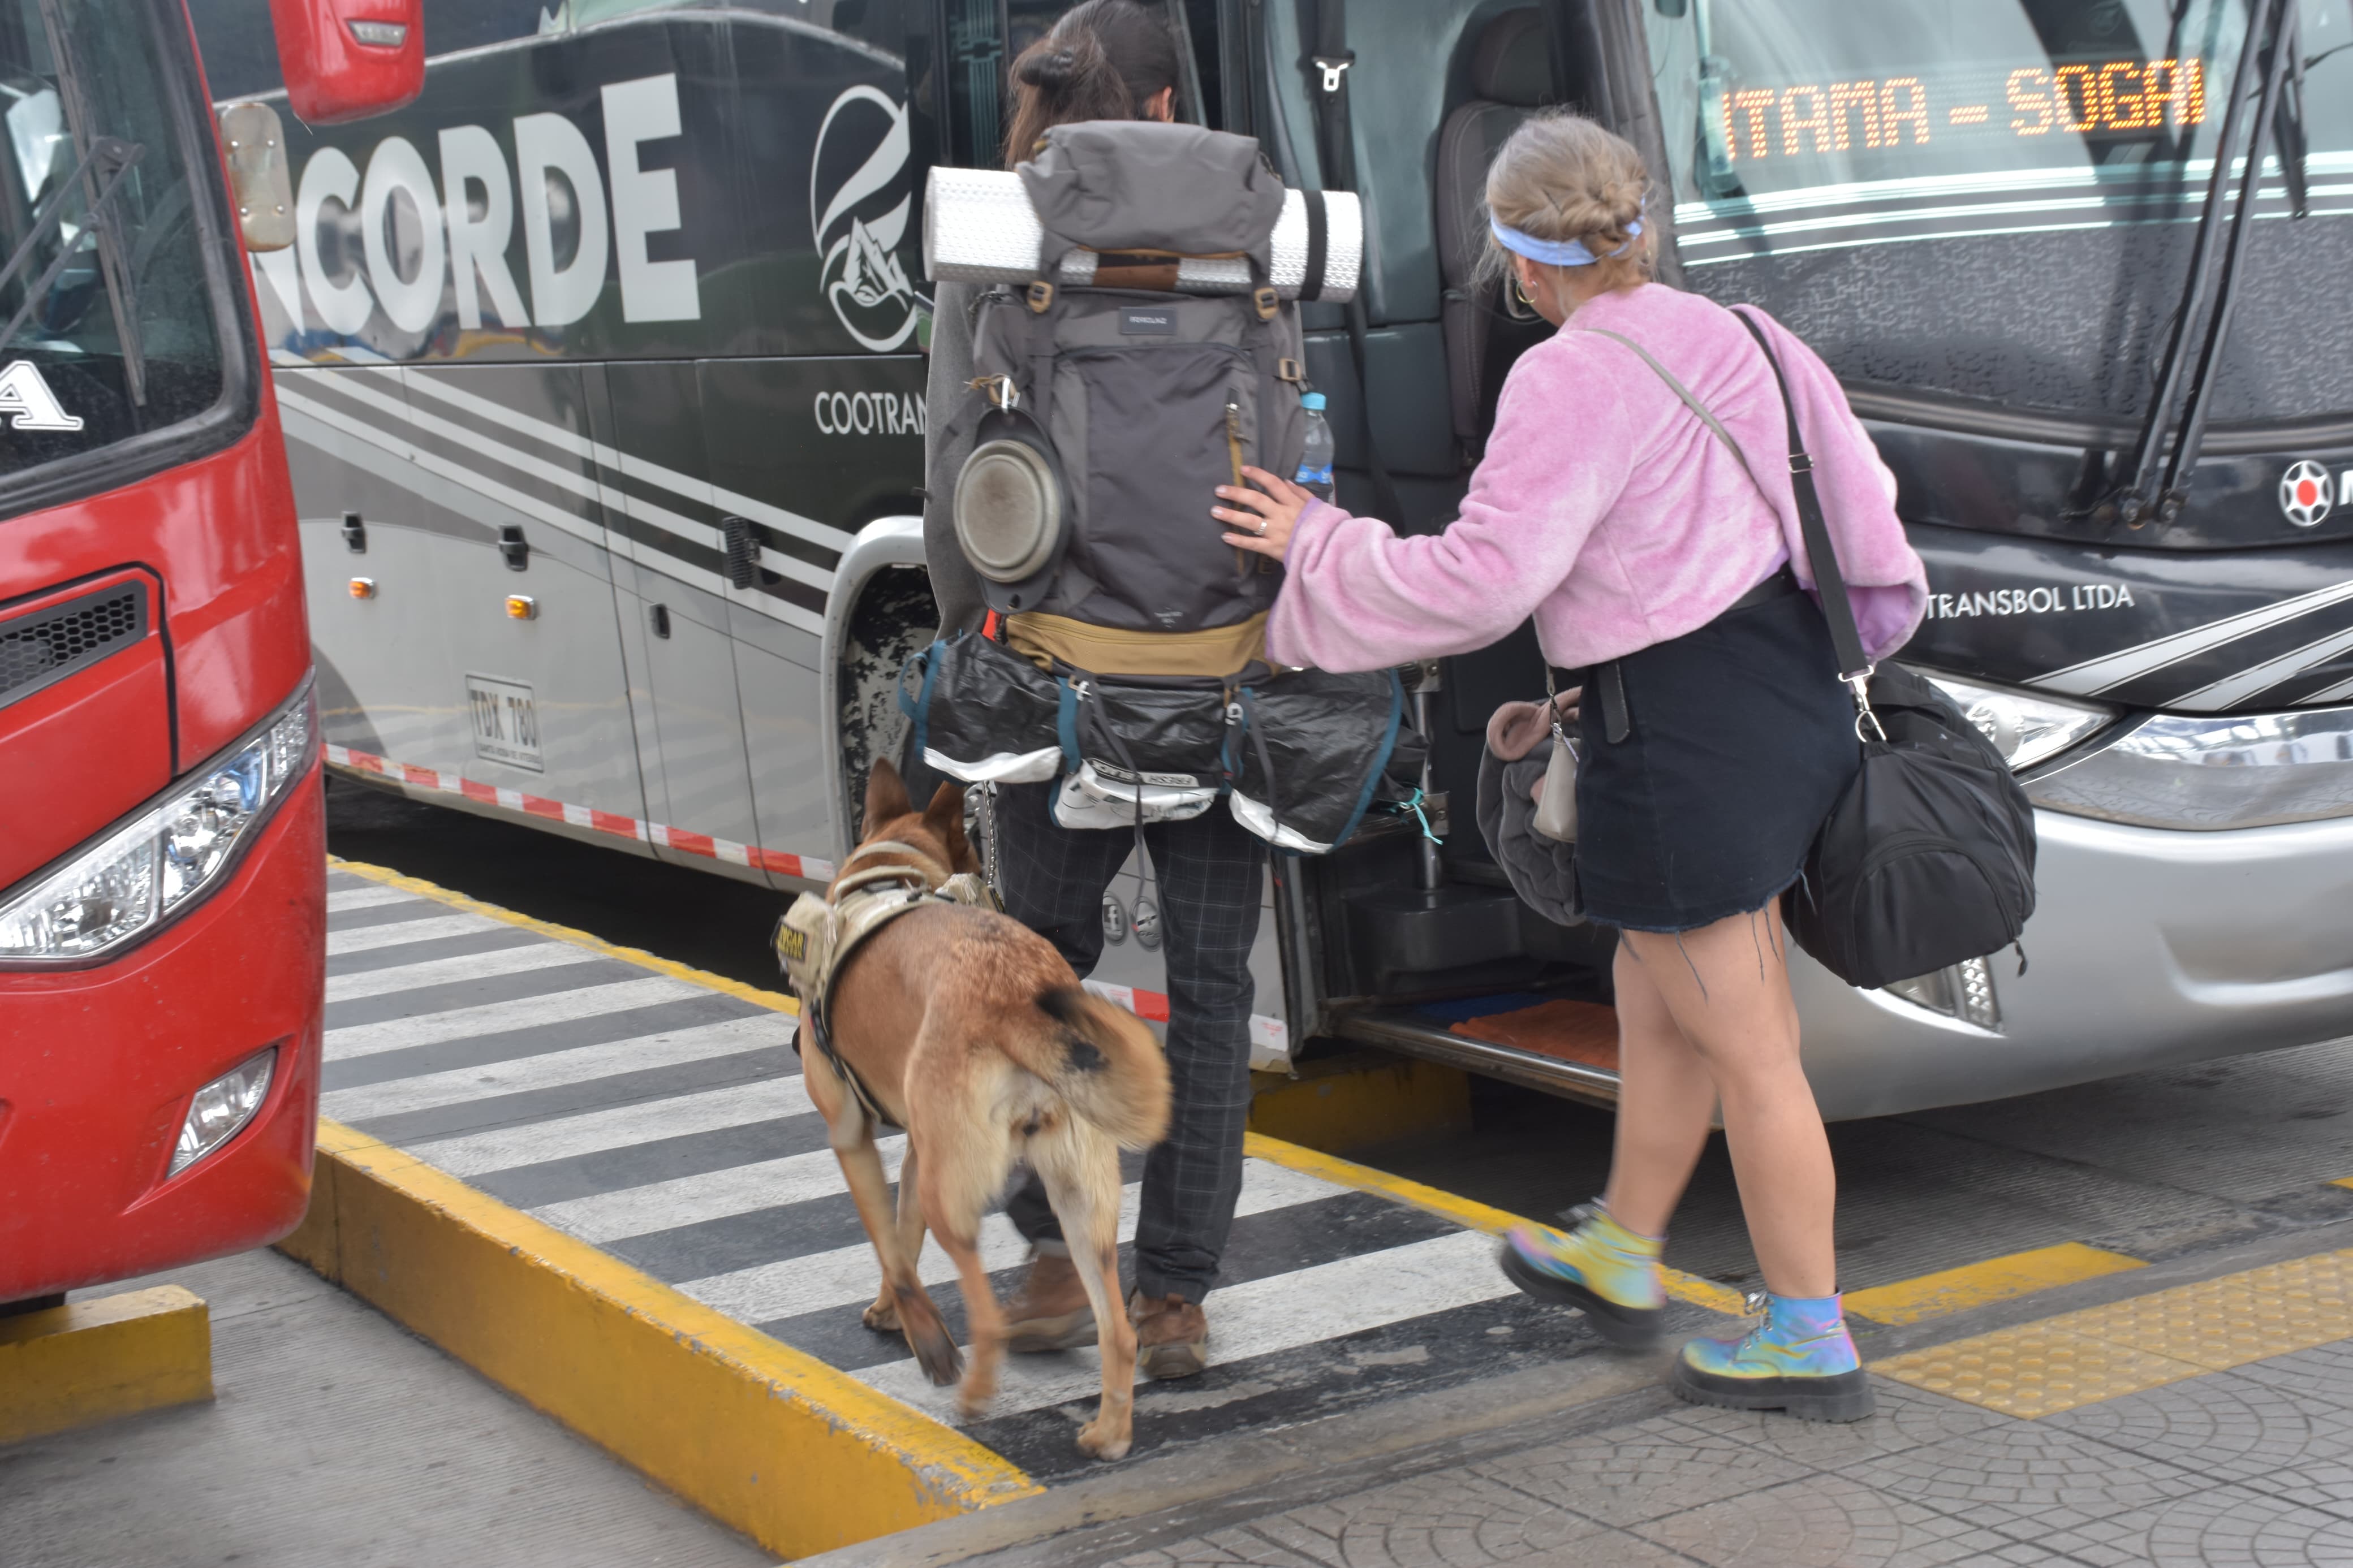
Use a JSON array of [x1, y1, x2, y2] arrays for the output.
[[1731, 310, 2035, 987]]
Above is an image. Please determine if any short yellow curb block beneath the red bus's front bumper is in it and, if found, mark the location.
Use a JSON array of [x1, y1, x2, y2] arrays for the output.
[[0, 1286, 212, 1444]]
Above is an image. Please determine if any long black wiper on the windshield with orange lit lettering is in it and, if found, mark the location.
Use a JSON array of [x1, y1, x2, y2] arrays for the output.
[[2101, 0, 2306, 529]]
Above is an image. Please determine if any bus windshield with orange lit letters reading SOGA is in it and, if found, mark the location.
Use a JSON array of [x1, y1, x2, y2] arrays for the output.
[[1645, 0, 2353, 421]]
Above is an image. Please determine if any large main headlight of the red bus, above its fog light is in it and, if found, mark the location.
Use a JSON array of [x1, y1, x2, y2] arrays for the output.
[[0, 679, 318, 969]]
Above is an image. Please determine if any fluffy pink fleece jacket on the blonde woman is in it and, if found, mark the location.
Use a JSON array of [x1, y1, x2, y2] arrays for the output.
[[1266, 284, 1927, 670]]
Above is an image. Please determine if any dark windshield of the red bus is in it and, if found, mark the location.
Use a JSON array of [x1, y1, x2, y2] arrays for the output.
[[0, 0, 223, 480]]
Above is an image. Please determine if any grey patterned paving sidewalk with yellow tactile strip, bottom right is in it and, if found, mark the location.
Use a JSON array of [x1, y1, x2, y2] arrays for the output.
[[812, 1227, 2353, 1568]]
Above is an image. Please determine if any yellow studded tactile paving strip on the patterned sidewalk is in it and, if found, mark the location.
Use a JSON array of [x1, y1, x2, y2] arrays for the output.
[[2045, 1249, 2353, 1371]]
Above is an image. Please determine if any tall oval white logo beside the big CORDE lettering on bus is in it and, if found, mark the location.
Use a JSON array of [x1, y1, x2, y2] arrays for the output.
[[809, 85, 917, 353]]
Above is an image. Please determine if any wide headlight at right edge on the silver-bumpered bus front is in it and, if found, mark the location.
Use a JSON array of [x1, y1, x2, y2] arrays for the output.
[[2026, 707, 2353, 830]]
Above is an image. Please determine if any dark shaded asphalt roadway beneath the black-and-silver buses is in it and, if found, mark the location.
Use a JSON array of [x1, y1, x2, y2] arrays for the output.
[[327, 783, 2353, 1290]]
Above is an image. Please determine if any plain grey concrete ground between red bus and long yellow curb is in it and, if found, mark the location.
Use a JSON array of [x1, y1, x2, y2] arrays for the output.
[[0, 1251, 777, 1568]]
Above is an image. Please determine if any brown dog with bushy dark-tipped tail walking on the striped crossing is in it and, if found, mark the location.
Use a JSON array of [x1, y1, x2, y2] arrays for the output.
[[800, 762, 1170, 1460]]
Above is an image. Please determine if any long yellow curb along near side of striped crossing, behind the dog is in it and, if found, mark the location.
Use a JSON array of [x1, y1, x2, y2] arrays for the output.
[[280, 1114, 1042, 1556]]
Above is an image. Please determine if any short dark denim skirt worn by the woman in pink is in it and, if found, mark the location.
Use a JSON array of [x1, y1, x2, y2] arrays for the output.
[[1576, 593, 1864, 931]]
